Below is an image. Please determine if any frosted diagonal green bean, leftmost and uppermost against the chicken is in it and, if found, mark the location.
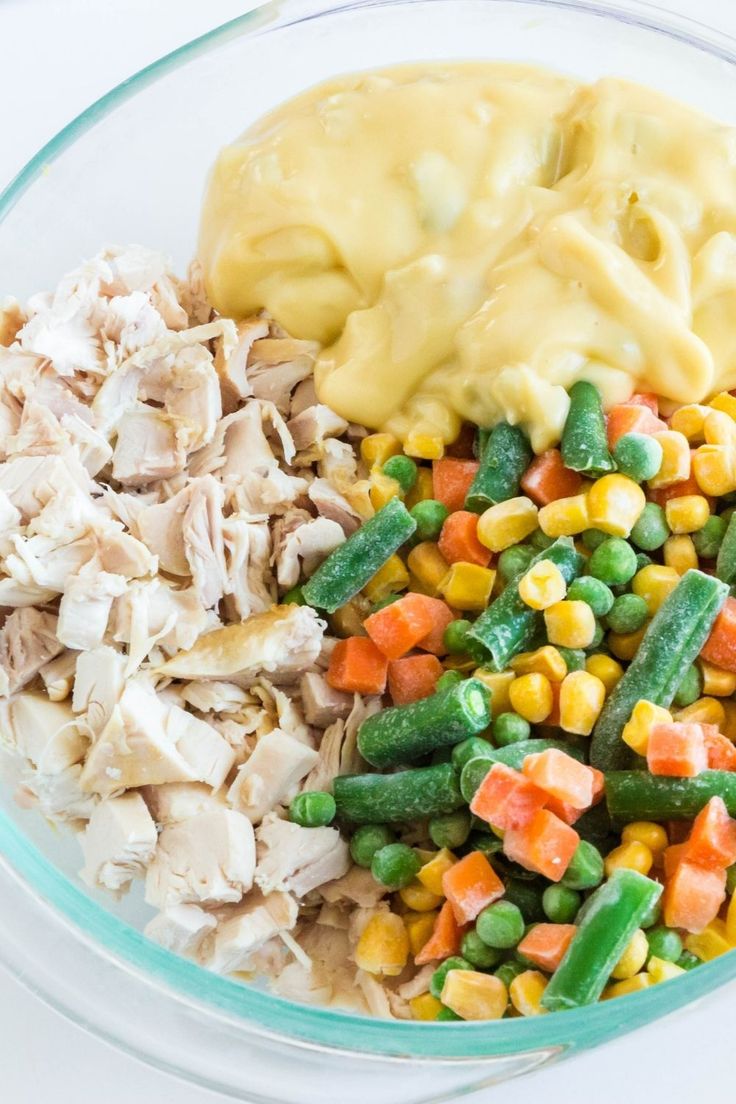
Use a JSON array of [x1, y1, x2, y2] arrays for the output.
[[303, 498, 416, 614]]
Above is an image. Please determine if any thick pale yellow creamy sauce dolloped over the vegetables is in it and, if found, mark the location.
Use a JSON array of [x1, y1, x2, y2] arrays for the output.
[[200, 63, 736, 450]]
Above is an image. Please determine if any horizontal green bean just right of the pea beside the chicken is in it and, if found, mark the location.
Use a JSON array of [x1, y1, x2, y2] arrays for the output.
[[333, 763, 463, 824]]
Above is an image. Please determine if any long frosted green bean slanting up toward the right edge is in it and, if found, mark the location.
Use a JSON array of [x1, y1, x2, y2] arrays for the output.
[[590, 571, 728, 768]]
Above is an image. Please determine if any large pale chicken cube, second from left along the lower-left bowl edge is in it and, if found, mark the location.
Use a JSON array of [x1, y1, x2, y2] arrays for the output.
[[146, 809, 256, 909]]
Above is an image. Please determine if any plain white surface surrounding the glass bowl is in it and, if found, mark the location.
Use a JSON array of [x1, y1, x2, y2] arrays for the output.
[[0, 0, 736, 1104]]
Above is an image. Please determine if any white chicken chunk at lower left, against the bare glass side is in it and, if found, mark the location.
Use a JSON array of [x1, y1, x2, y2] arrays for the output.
[[79, 794, 158, 893]]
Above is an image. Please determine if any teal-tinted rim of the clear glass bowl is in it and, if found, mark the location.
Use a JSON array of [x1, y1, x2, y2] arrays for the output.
[[0, 0, 736, 1061]]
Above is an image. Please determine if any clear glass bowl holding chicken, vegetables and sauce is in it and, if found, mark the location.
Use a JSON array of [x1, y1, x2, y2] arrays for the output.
[[0, 0, 736, 1104]]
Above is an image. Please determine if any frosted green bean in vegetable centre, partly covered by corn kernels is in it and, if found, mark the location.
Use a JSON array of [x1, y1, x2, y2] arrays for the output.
[[468, 537, 583, 671]]
